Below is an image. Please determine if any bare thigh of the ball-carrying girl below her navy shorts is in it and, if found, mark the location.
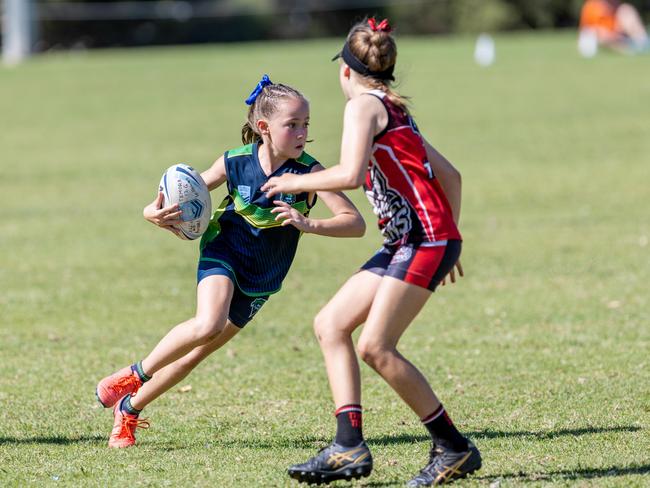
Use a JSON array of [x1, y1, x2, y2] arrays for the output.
[[196, 275, 235, 328]]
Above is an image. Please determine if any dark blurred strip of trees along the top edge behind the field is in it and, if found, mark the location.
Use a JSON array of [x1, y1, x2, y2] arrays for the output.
[[27, 0, 650, 49]]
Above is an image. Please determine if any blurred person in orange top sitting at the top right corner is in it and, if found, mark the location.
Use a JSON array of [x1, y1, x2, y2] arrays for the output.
[[580, 0, 650, 54]]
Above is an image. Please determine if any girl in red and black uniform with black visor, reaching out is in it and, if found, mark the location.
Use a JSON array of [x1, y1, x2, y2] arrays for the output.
[[262, 19, 481, 487]]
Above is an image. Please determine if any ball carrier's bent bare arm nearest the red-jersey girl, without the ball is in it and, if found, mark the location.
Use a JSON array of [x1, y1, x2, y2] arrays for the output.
[[271, 164, 366, 237]]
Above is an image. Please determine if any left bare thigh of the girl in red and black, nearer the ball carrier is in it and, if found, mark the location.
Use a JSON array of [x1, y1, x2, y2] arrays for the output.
[[315, 270, 382, 333]]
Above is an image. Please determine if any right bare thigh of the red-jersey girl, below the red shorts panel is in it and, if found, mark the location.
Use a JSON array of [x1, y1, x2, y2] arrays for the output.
[[359, 276, 431, 348]]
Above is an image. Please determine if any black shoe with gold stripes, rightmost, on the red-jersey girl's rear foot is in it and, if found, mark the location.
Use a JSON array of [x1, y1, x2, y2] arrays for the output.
[[406, 441, 481, 488]]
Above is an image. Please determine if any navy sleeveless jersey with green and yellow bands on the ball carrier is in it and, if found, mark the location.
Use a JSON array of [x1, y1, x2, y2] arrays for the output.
[[200, 143, 318, 296]]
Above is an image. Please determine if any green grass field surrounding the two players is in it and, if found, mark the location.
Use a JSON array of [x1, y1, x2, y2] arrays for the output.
[[0, 34, 650, 487]]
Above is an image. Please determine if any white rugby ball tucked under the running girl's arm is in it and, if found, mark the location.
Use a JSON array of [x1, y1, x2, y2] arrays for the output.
[[160, 164, 212, 240]]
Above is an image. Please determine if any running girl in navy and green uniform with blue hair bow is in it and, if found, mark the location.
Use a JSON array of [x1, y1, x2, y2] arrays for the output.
[[96, 75, 365, 448]]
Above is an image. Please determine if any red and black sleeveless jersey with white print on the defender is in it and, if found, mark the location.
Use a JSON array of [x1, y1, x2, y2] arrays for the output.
[[364, 90, 461, 245]]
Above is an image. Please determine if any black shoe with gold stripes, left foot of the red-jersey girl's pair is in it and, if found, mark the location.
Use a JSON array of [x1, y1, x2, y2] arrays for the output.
[[289, 442, 372, 485]]
